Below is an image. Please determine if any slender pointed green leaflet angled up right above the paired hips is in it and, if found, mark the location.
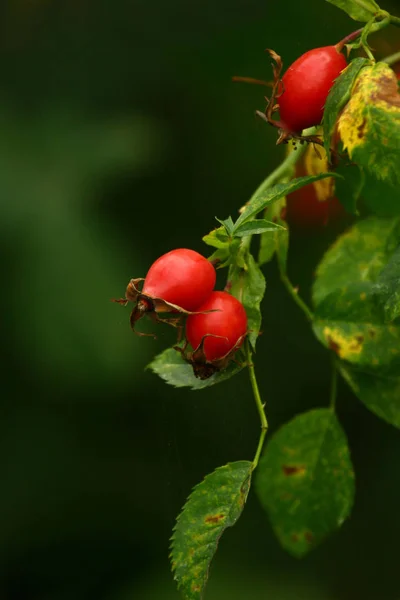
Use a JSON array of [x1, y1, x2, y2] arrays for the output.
[[233, 173, 338, 234]]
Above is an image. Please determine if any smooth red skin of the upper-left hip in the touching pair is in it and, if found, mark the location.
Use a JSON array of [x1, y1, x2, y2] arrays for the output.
[[142, 248, 216, 311]]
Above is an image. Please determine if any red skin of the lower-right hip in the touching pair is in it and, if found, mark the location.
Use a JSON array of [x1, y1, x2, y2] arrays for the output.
[[186, 292, 247, 362]]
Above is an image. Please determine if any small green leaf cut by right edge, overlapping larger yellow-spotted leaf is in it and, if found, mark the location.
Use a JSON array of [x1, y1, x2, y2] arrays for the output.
[[373, 246, 400, 322]]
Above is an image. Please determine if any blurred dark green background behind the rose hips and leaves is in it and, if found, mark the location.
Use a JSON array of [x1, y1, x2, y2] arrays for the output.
[[0, 0, 400, 600]]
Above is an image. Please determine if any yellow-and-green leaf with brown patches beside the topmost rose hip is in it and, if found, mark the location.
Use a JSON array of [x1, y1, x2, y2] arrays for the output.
[[339, 63, 400, 185]]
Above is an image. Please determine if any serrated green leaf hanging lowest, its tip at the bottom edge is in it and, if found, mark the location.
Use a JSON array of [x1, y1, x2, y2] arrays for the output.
[[170, 461, 253, 600]]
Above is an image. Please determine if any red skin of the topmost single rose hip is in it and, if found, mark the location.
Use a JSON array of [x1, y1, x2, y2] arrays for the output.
[[278, 46, 347, 132]]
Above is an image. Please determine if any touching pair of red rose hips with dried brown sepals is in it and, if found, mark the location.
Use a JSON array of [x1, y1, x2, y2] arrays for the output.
[[115, 248, 247, 379]]
